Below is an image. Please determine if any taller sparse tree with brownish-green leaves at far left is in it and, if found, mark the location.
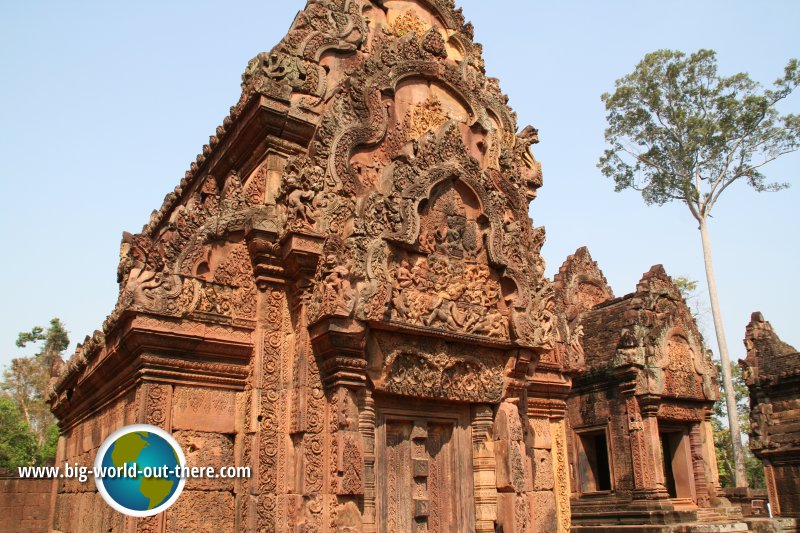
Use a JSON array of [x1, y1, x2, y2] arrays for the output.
[[0, 318, 69, 464]]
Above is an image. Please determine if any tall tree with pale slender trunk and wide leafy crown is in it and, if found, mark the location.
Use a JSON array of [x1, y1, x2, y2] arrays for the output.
[[598, 50, 800, 486]]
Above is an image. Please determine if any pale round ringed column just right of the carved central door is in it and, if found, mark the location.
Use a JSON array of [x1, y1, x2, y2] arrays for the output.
[[471, 404, 497, 533]]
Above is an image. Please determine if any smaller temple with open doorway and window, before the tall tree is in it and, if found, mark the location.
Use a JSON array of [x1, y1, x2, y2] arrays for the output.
[[554, 248, 746, 531]]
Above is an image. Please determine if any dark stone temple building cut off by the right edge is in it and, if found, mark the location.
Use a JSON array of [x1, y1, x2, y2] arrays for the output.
[[739, 313, 800, 524]]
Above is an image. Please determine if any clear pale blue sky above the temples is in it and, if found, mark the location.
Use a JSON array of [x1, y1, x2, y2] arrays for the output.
[[0, 0, 800, 365]]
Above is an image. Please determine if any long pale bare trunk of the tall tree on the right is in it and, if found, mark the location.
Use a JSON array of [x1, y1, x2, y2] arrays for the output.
[[700, 219, 747, 487]]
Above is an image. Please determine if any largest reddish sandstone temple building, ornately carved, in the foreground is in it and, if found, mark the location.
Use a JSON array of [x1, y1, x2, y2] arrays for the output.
[[50, 0, 588, 533]]
